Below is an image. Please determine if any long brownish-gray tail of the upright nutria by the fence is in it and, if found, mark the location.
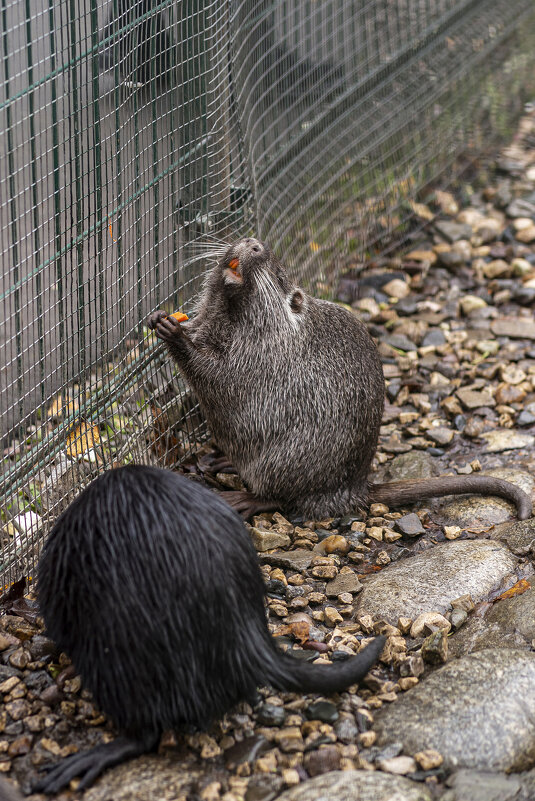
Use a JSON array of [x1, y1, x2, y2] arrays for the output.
[[368, 475, 532, 520]]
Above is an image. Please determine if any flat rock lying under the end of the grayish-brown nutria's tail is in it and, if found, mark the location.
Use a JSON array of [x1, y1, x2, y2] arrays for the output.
[[434, 467, 534, 529]]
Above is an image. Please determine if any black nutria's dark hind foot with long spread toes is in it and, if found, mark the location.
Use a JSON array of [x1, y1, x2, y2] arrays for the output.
[[32, 737, 159, 795]]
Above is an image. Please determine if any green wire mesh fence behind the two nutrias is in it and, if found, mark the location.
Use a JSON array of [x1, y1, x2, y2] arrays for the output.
[[0, 0, 535, 583]]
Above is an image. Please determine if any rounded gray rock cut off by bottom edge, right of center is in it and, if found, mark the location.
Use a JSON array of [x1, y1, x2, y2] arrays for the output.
[[278, 770, 431, 801]]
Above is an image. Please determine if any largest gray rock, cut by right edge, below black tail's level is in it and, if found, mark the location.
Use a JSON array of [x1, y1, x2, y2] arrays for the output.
[[375, 649, 535, 772]]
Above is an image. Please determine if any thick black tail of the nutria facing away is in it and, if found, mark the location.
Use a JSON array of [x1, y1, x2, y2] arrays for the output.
[[264, 636, 386, 695]]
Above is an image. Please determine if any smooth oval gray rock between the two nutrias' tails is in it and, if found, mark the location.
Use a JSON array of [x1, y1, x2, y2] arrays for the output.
[[357, 540, 517, 620]]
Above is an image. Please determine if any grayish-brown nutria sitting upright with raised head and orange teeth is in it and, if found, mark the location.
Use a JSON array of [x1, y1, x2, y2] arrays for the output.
[[149, 238, 531, 520]]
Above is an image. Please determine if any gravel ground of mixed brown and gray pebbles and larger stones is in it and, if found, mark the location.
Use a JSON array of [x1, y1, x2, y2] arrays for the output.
[[5, 116, 535, 801]]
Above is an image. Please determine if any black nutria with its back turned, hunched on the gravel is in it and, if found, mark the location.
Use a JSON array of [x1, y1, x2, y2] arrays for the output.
[[35, 466, 384, 793]]
